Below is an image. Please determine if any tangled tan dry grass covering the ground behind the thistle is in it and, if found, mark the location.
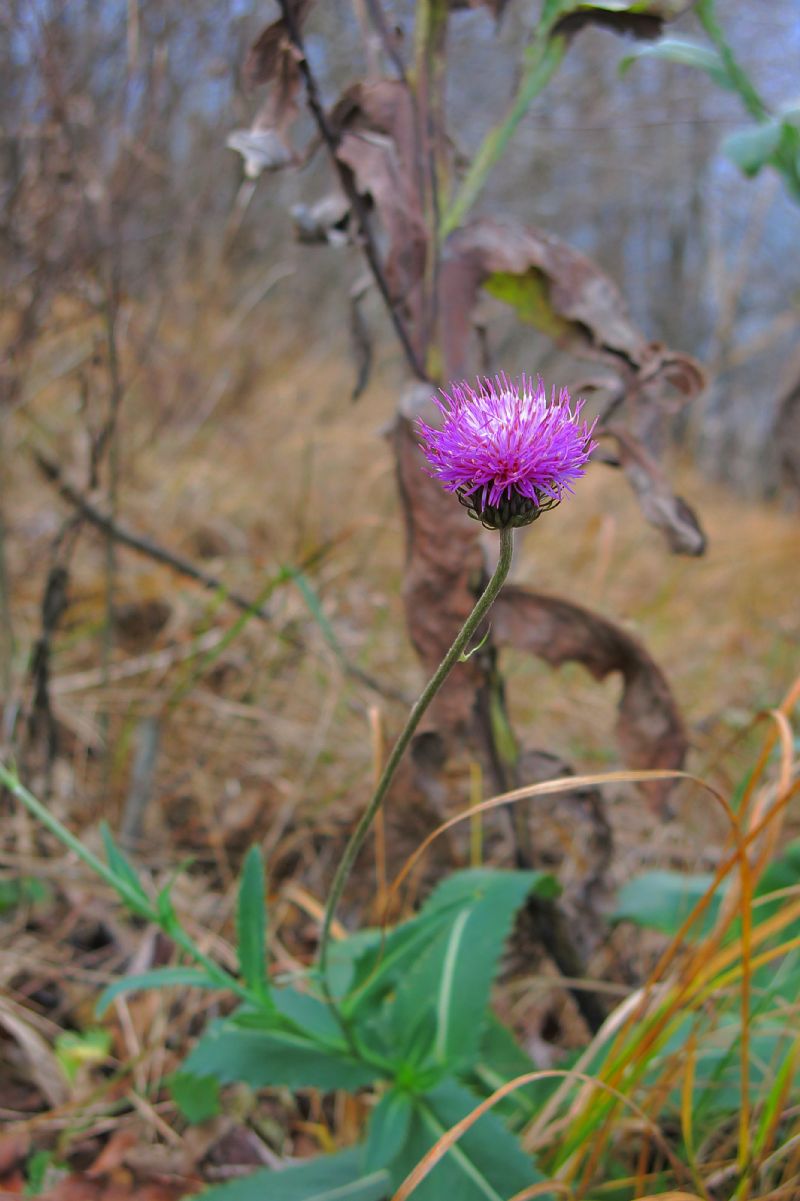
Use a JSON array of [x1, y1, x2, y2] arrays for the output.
[[0, 293, 800, 1197]]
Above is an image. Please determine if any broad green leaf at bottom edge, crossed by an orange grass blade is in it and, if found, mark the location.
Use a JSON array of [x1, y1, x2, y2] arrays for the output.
[[389, 1080, 547, 1201]]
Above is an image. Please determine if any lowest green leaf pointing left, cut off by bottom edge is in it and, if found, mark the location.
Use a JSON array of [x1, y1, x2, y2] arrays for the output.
[[197, 1148, 389, 1201]]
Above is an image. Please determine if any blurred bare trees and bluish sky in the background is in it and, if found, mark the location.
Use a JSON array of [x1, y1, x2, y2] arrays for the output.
[[0, 0, 800, 492]]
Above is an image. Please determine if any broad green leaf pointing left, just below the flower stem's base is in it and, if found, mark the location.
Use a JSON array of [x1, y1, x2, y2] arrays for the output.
[[181, 1021, 378, 1091]]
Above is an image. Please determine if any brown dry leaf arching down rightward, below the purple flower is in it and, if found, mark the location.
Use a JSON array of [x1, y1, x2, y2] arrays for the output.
[[491, 585, 688, 800]]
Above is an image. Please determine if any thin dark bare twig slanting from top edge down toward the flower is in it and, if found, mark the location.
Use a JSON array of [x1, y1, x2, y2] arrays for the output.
[[273, 0, 428, 380]]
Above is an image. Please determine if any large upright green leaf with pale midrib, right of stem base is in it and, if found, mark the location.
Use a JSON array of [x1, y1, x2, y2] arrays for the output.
[[390, 868, 557, 1070]]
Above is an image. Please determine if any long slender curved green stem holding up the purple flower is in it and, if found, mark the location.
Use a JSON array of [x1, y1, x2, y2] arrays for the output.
[[320, 528, 514, 984]]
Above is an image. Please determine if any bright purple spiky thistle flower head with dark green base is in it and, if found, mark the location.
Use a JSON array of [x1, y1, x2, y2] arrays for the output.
[[417, 375, 597, 530]]
